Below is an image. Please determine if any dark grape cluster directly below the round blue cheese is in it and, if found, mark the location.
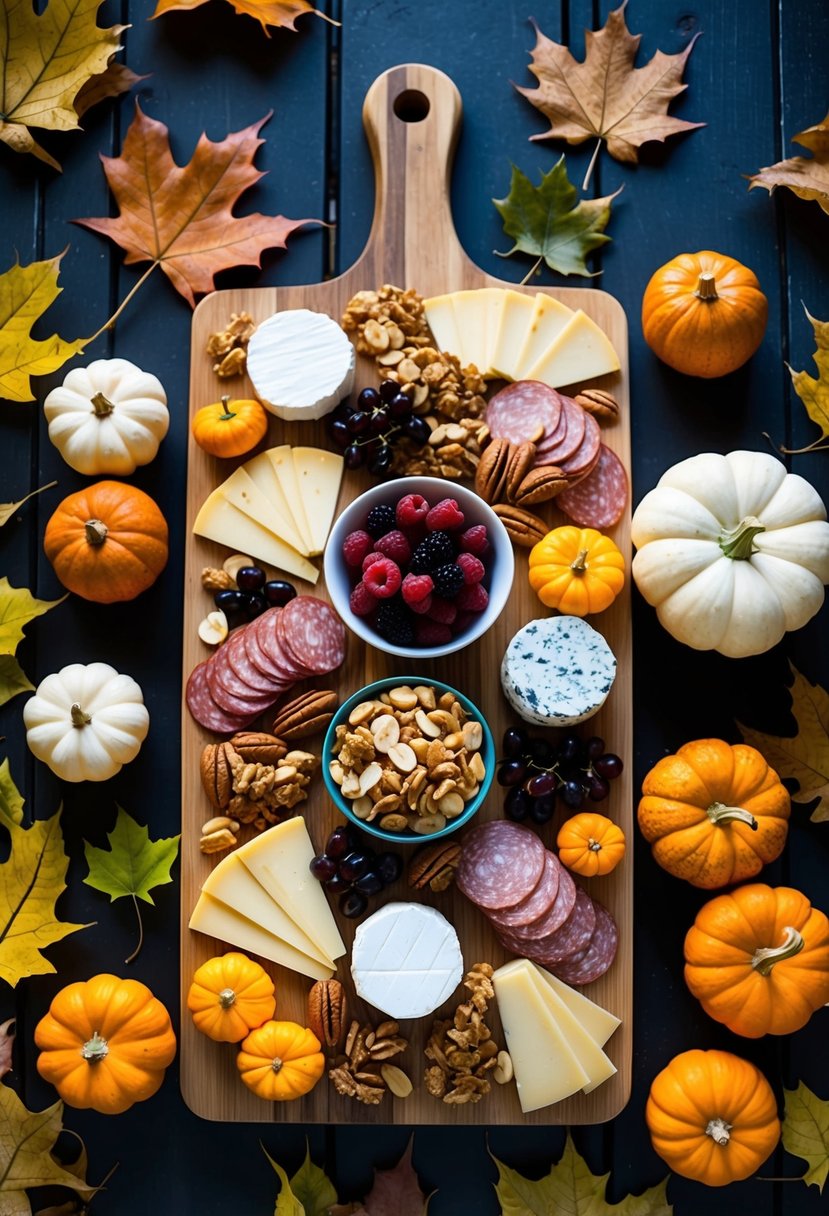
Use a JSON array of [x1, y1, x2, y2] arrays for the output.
[[497, 726, 624, 823]]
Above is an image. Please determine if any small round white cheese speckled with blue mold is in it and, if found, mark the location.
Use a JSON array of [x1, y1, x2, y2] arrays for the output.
[[501, 617, 616, 726]]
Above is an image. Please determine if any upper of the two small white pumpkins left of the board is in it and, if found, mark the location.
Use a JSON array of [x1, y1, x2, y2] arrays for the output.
[[44, 359, 170, 477]]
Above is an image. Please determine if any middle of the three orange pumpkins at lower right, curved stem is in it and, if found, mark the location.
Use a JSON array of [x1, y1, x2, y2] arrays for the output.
[[686, 883, 829, 1038]]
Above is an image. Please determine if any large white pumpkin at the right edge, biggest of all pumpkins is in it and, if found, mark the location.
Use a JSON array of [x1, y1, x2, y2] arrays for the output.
[[631, 451, 829, 659]]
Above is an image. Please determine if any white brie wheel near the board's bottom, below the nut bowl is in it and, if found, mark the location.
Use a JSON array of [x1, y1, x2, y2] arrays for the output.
[[351, 903, 463, 1019]]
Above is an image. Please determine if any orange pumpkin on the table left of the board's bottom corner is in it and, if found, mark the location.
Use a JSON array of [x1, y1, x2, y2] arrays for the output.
[[34, 974, 175, 1115]]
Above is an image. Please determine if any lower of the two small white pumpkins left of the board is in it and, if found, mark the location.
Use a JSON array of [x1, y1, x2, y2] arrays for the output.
[[23, 663, 150, 781]]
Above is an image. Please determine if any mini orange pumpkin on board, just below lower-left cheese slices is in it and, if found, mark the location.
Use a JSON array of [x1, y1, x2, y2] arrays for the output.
[[187, 951, 276, 1043]]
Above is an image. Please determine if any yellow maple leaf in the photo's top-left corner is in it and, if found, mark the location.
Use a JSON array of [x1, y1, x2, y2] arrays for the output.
[[0, 0, 128, 169]]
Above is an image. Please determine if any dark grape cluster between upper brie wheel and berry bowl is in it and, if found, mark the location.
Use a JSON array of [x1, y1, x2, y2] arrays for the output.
[[329, 381, 430, 477]]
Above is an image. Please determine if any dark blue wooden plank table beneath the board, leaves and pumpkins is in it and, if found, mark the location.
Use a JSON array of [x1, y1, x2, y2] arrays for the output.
[[0, 0, 829, 1216]]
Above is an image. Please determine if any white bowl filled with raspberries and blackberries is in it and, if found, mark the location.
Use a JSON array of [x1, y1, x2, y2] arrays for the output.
[[323, 477, 514, 659]]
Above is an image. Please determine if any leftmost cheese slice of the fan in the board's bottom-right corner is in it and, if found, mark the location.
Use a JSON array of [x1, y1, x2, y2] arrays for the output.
[[492, 959, 590, 1114]]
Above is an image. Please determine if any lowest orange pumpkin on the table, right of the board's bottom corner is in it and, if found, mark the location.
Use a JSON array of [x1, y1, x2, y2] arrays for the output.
[[645, 1051, 780, 1187]]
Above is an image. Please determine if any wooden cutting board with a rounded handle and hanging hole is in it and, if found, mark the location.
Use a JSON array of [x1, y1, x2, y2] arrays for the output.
[[181, 63, 633, 1125]]
